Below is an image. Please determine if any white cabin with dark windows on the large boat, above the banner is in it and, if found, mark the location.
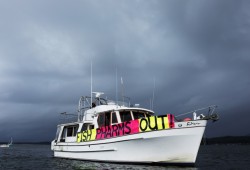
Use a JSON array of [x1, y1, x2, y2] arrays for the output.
[[55, 106, 154, 142]]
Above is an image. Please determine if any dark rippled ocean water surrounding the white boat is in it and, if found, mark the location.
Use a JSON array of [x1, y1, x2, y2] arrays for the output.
[[0, 144, 250, 170]]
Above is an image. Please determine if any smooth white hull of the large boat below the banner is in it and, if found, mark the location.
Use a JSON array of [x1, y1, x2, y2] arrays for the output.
[[51, 120, 207, 164]]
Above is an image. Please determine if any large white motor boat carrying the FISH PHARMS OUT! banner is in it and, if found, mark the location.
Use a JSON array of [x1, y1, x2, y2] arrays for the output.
[[51, 93, 218, 165]]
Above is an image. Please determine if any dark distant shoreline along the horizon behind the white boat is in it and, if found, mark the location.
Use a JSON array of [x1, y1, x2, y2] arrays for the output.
[[0, 136, 250, 145]]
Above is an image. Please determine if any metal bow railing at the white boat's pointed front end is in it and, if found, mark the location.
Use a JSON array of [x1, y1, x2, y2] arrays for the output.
[[175, 105, 219, 121]]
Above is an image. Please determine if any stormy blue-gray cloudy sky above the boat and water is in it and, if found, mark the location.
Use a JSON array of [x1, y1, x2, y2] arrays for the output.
[[0, 0, 250, 141]]
